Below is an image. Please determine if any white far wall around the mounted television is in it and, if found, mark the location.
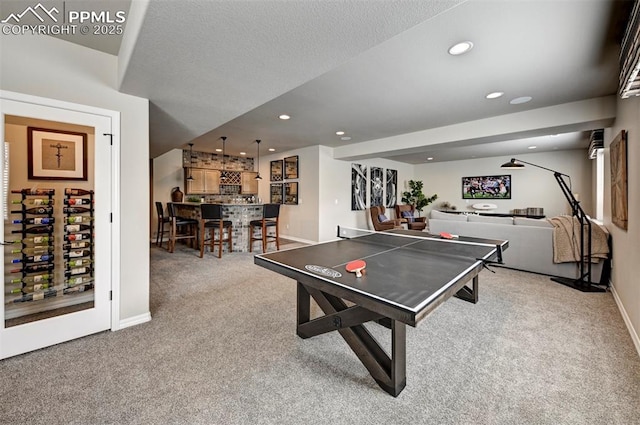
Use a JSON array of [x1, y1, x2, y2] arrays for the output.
[[415, 150, 594, 217]]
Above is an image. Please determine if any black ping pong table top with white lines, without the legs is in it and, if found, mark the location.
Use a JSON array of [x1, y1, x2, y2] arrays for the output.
[[254, 230, 507, 326]]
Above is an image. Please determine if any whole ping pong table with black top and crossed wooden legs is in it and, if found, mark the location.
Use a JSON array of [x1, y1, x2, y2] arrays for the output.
[[254, 227, 508, 397]]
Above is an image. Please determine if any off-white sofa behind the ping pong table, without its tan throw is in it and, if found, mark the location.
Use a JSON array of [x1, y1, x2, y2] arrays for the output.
[[429, 210, 604, 283]]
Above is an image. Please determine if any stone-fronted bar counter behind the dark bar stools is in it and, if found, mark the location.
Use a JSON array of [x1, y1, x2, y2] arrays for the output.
[[173, 202, 264, 252]]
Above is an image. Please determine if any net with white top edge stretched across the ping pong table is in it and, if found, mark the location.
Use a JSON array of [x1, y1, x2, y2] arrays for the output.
[[337, 226, 505, 266]]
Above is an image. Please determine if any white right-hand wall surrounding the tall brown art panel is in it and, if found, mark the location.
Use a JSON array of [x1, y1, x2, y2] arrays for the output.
[[604, 97, 640, 353]]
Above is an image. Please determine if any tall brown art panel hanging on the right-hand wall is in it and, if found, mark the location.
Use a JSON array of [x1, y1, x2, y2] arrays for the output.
[[609, 130, 629, 230]]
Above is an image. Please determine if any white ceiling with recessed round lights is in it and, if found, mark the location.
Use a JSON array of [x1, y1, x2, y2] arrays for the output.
[[28, 0, 631, 163]]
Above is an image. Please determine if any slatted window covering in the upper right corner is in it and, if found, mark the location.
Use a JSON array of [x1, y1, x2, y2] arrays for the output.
[[619, 2, 640, 99]]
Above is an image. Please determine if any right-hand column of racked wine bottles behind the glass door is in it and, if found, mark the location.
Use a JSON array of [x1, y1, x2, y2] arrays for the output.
[[62, 188, 95, 293]]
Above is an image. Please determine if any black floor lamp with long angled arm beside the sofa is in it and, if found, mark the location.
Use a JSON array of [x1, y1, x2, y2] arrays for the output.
[[501, 158, 605, 292]]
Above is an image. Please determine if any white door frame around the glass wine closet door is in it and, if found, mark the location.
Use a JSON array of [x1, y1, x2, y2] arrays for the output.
[[0, 90, 121, 354]]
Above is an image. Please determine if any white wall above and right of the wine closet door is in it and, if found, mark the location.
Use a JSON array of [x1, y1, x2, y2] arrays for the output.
[[0, 35, 149, 322]]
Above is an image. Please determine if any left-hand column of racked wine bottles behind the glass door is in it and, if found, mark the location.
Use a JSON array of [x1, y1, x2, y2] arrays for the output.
[[9, 189, 56, 302]]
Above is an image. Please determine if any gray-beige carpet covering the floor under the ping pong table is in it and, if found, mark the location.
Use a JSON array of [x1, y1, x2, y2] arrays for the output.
[[0, 245, 640, 425]]
